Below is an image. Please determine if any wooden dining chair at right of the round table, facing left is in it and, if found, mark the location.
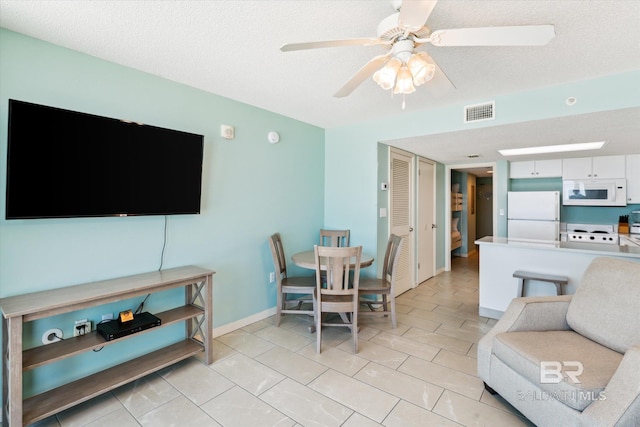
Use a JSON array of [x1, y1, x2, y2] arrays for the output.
[[358, 234, 404, 329]]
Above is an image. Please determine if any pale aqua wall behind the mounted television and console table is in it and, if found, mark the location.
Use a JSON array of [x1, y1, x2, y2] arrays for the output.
[[0, 29, 322, 395]]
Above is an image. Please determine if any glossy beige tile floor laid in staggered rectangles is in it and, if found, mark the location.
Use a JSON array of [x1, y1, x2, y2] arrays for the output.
[[26, 256, 533, 427]]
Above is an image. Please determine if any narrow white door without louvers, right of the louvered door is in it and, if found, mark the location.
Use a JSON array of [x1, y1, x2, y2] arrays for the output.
[[417, 159, 436, 283]]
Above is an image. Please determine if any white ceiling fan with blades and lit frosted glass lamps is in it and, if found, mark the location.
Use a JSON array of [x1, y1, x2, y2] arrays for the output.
[[280, 0, 555, 98]]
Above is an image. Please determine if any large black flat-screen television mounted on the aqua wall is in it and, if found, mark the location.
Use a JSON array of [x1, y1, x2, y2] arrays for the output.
[[6, 100, 204, 219]]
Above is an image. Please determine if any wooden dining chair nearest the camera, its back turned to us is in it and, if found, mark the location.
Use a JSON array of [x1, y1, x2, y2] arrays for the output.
[[313, 245, 362, 353]]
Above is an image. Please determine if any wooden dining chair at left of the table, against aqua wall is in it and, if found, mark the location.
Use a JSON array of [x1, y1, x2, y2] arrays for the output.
[[269, 233, 316, 326]]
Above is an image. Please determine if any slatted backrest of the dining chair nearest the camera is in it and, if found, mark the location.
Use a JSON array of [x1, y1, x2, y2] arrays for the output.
[[314, 245, 362, 295]]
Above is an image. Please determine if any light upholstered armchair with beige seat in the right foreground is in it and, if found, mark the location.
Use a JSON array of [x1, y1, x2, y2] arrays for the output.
[[478, 257, 640, 427]]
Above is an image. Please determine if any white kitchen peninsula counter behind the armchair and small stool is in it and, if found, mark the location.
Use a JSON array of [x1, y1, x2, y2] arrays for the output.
[[475, 236, 640, 319]]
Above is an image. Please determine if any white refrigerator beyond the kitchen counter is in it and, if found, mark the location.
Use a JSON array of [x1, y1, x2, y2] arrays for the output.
[[507, 191, 560, 243]]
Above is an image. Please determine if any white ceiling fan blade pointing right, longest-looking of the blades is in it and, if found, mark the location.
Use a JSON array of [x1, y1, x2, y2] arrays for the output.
[[431, 25, 556, 46]]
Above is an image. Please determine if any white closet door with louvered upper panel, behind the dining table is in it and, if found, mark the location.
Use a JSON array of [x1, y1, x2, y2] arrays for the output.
[[389, 148, 415, 295]]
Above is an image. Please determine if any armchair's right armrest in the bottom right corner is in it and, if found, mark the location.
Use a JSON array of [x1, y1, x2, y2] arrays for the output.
[[581, 344, 640, 426]]
